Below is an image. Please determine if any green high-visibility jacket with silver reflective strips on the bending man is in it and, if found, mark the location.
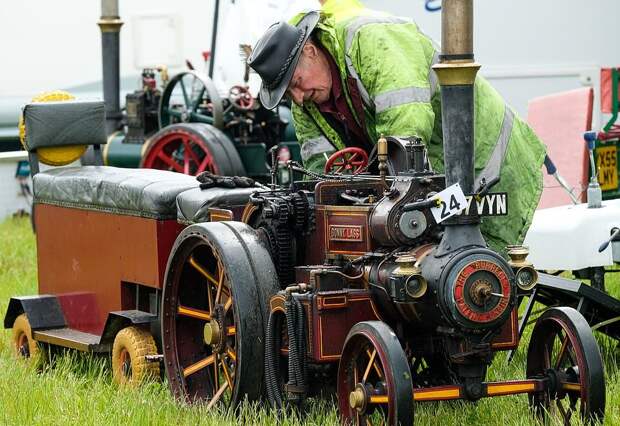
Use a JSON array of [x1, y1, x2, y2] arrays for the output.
[[292, 0, 545, 252]]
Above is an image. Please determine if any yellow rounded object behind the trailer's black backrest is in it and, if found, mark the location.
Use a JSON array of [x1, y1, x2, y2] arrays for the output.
[[19, 90, 87, 166]]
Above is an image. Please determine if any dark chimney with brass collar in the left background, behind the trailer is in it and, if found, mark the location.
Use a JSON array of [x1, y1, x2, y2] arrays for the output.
[[98, 0, 123, 134]]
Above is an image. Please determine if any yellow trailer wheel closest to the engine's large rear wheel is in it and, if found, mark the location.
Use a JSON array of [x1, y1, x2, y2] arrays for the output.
[[112, 326, 159, 386]]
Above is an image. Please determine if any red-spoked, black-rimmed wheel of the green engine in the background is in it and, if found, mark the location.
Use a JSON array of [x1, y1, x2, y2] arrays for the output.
[[140, 123, 246, 176]]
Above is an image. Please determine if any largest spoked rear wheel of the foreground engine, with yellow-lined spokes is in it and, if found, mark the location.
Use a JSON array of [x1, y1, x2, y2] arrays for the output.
[[162, 222, 279, 408]]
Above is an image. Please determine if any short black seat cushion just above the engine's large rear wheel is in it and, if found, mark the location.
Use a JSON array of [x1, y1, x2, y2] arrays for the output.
[[177, 187, 265, 224]]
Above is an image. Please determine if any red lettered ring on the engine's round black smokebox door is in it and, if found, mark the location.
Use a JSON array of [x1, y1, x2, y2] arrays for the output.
[[454, 260, 511, 323]]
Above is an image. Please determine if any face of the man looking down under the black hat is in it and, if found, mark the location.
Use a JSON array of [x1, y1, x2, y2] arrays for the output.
[[286, 43, 332, 105]]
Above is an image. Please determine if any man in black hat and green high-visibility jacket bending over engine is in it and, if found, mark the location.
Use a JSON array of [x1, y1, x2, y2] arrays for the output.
[[250, 0, 545, 251]]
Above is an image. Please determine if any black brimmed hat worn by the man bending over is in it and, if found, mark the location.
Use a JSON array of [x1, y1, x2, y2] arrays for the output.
[[248, 11, 320, 109]]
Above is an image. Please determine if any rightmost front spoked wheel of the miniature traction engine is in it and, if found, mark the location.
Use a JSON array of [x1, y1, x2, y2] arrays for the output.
[[527, 307, 605, 424]]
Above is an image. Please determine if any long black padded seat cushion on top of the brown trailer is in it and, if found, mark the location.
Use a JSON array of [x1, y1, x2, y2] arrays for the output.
[[33, 166, 199, 220]]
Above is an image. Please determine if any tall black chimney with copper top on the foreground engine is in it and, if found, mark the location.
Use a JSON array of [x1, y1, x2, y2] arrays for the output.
[[433, 0, 486, 254]]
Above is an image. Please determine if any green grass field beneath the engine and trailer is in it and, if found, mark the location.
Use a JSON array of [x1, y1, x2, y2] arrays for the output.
[[0, 218, 620, 426]]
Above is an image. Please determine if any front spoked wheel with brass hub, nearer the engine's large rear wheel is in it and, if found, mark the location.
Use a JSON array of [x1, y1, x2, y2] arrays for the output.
[[338, 321, 413, 425]]
